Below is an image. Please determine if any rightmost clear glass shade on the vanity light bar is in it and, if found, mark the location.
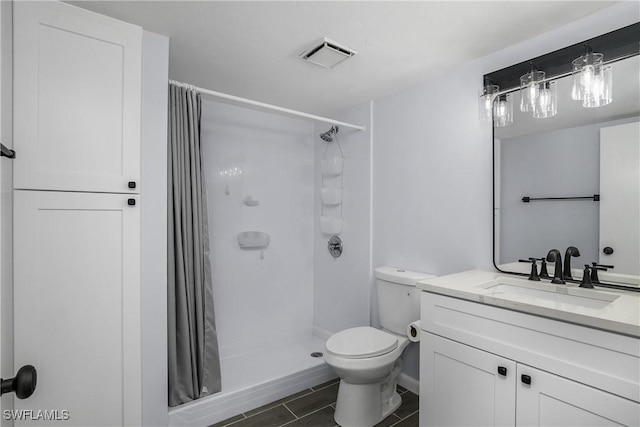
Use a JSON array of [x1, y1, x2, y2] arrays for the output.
[[571, 45, 613, 108]]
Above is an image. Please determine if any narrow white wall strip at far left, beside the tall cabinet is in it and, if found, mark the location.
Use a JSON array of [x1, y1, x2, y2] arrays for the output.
[[0, 1, 15, 426]]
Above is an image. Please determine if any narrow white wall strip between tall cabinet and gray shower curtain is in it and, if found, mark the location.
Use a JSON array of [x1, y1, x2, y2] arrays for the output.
[[140, 31, 169, 426]]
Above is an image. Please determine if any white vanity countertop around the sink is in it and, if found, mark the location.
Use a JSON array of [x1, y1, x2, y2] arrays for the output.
[[416, 270, 640, 337]]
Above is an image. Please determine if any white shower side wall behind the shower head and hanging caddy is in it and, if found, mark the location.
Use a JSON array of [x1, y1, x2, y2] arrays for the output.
[[313, 103, 372, 339]]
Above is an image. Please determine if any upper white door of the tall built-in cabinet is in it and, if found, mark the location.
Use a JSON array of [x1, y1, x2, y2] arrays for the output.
[[14, 1, 142, 193]]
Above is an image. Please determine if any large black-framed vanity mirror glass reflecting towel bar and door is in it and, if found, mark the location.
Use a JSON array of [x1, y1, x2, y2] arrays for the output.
[[494, 56, 640, 285]]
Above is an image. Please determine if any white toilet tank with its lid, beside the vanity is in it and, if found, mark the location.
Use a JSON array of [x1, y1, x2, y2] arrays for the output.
[[375, 267, 435, 335]]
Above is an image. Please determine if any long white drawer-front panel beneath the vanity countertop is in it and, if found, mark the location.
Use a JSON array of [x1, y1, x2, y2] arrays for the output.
[[421, 292, 640, 402]]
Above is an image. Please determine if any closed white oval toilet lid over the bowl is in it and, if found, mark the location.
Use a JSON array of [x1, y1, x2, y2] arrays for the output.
[[326, 326, 398, 359]]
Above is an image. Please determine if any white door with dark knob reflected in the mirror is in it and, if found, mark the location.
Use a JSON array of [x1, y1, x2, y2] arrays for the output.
[[600, 122, 640, 275]]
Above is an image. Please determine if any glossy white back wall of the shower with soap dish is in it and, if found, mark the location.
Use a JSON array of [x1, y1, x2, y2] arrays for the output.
[[202, 101, 317, 357]]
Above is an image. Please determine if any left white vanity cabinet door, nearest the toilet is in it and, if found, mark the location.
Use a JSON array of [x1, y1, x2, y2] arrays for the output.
[[420, 331, 516, 426]]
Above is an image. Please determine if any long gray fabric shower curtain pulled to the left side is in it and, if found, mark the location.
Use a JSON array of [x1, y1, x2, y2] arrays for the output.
[[167, 82, 221, 406]]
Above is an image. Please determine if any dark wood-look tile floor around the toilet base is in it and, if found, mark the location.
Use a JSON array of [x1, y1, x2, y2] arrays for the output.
[[211, 378, 418, 427]]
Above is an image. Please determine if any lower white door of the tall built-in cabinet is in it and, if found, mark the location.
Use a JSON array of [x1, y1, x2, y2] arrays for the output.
[[14, 190, 141, 426]]
